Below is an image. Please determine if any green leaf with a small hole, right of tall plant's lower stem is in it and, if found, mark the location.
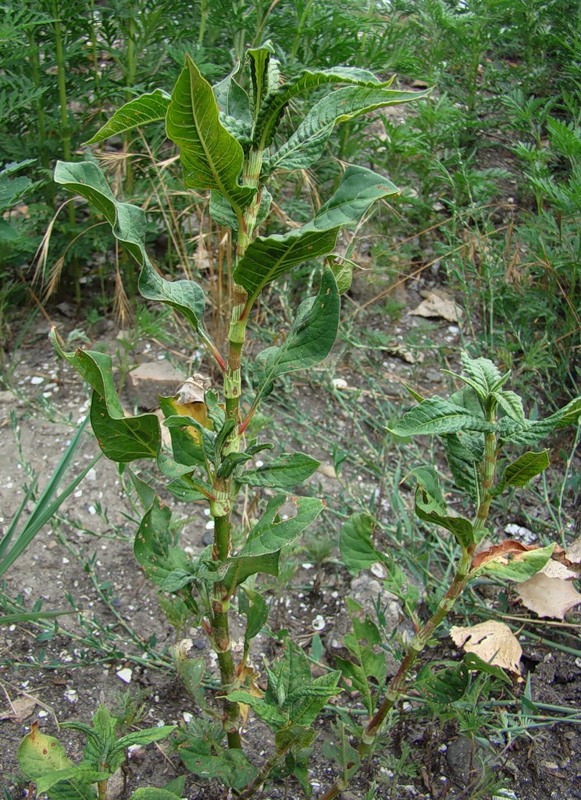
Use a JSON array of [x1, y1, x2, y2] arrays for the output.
[[238, 495, 325, 557]]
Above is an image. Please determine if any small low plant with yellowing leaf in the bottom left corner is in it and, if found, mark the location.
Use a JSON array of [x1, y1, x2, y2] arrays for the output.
[[18, 705, 177, 800]]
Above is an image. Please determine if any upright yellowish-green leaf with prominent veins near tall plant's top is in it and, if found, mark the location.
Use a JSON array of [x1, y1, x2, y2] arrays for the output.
[[166, 56, 256, 213]]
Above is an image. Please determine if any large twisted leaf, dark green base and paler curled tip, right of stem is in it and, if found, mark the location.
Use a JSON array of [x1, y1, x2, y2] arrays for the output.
[[234, 167, 398, 305]]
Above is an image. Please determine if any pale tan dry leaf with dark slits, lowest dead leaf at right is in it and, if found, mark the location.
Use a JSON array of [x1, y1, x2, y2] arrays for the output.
[[450, 620, 522, 675]]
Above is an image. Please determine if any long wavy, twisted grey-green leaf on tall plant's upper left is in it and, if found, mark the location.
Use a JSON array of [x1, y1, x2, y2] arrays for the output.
[[54, 161, 210, 343]]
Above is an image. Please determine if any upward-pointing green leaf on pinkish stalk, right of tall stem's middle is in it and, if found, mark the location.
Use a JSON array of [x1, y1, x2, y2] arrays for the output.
[[256, 270, 340, 395]]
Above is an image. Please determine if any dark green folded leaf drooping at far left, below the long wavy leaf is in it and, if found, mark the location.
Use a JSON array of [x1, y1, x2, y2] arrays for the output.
[[50, 331, 161, 463]]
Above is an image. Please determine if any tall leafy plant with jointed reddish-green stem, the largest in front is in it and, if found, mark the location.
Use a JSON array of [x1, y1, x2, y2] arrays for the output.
[[53, 44, 425, 793]]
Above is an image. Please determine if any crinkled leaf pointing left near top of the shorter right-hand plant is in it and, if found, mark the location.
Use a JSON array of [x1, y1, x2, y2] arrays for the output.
[[390, 397, 494, 436]]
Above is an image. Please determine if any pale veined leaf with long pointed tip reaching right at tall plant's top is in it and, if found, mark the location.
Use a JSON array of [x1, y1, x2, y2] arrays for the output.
[[268, 81, 428, 170]]
